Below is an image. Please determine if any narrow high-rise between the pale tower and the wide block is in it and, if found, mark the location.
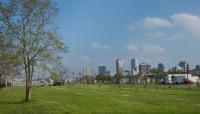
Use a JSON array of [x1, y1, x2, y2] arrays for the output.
[[131, 59, 139, 75]]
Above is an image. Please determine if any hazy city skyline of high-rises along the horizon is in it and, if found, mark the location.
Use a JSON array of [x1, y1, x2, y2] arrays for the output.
[[79, 58, 200, 76]]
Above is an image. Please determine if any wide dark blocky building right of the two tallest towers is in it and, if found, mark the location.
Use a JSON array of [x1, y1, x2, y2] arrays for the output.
[[139, 63, 151, 74]]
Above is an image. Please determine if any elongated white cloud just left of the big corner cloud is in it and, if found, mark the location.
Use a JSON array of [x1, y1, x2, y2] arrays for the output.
[[141, 17, 174, 28]]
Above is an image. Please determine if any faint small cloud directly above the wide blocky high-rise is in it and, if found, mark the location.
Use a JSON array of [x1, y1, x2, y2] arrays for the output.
[[143, 44, 165, 54]]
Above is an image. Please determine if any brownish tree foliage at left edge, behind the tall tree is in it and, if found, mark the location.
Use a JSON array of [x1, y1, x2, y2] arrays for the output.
[[0, 33, 20, 87]]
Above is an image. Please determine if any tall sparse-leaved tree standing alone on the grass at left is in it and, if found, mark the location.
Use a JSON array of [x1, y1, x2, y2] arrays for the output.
[[0, 0, 67, 101]]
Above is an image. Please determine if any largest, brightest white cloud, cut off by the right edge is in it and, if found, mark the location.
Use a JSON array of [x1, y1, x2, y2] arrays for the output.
[[171, 13, 200, 37]]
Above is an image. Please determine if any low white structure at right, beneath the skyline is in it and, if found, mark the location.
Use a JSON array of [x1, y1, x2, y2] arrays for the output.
[[165, 73, 200, 83]]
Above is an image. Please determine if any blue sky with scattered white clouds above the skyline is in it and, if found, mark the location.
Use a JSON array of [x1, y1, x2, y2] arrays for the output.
[[54, 0, 200, 73]]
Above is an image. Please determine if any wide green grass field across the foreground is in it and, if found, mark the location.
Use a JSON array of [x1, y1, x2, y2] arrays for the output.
[[0, 85, 200, 114]]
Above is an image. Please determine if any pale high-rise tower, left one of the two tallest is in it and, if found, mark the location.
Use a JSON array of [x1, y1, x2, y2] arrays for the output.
[[116, 59, 125, 76]]
